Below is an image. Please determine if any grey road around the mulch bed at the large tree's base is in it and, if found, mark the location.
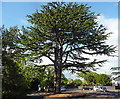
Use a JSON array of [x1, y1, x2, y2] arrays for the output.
[[28, 88, 120, 99]]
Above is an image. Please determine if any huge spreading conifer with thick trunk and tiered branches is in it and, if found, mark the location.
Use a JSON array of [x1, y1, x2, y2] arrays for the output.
[[4, 2, 115, 93]]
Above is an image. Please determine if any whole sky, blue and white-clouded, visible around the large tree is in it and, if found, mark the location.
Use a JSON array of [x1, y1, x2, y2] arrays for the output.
[[2, 0, 118, 79]]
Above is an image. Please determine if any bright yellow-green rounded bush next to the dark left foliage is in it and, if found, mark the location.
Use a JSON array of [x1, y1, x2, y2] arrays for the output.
[[20, 63, 46, 89]]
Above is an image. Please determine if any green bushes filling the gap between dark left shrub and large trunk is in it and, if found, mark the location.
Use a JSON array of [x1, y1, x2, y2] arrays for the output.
[[21, 63, 54, 90]]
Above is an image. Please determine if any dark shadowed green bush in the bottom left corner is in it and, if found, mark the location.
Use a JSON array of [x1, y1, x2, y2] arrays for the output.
[[2, 57, 26, 99]]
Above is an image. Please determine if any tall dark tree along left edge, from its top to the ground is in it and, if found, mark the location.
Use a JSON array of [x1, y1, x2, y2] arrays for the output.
[[2, 28, 26, 99]]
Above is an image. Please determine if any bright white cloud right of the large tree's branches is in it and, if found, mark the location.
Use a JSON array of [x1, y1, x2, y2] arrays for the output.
[[94, 15, 118, 74]]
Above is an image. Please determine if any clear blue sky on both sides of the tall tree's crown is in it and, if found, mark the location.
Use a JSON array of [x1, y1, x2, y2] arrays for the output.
[[2, 2, 118, 27]]
